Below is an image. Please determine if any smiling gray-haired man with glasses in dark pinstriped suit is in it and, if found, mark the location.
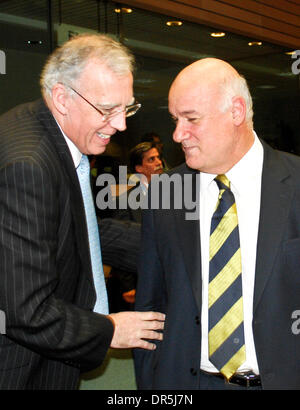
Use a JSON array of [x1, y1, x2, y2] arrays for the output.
[[0, 35, 163, 389]]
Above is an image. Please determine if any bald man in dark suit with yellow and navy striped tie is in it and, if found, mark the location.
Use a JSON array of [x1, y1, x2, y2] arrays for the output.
[[135, 59, 300, 389]]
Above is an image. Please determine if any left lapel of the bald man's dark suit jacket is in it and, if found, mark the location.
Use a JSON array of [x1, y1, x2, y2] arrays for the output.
[[174, 167, 202, 312]]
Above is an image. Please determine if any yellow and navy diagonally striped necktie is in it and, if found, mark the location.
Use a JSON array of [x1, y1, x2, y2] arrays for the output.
[[208, 175, 246, 380]]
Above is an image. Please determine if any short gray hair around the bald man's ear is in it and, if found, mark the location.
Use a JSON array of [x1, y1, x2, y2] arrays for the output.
[[220, 74, 253, 126]]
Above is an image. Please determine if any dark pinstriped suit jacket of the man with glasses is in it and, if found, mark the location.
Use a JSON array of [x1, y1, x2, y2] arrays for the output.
[[0, 100, 113, 389]]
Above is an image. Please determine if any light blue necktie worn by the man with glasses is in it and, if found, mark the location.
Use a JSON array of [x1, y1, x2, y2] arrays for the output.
[[77, 155, 108, 315]]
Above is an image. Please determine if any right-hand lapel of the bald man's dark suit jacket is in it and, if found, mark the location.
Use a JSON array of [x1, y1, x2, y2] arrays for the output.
[[253, 143, 293, 312]]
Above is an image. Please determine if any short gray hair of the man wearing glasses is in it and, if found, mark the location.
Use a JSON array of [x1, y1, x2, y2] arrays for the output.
[[40, 34, 134, 95]]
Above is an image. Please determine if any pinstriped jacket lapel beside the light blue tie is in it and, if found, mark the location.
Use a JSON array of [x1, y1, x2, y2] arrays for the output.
[[37, 101, 94, 284]]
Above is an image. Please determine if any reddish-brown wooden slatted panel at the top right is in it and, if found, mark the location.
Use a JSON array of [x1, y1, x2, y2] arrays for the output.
[[119, 0, 300, 49]]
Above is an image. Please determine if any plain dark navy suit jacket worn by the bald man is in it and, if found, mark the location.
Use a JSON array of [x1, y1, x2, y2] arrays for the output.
[[134, 144, 300, 389]]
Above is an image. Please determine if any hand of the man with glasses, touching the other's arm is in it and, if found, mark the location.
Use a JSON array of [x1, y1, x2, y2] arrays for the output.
[[108, 312, 165, 350]]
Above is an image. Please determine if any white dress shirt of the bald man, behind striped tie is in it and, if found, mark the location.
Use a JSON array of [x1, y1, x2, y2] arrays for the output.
[[200, 133, 263, 374]]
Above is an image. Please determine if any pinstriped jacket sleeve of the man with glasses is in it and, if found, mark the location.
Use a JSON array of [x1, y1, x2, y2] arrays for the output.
[[0, 159, 114, 370]]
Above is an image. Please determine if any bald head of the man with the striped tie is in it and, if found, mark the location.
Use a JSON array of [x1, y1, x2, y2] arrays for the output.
[[169, 58, 253, 174]]
